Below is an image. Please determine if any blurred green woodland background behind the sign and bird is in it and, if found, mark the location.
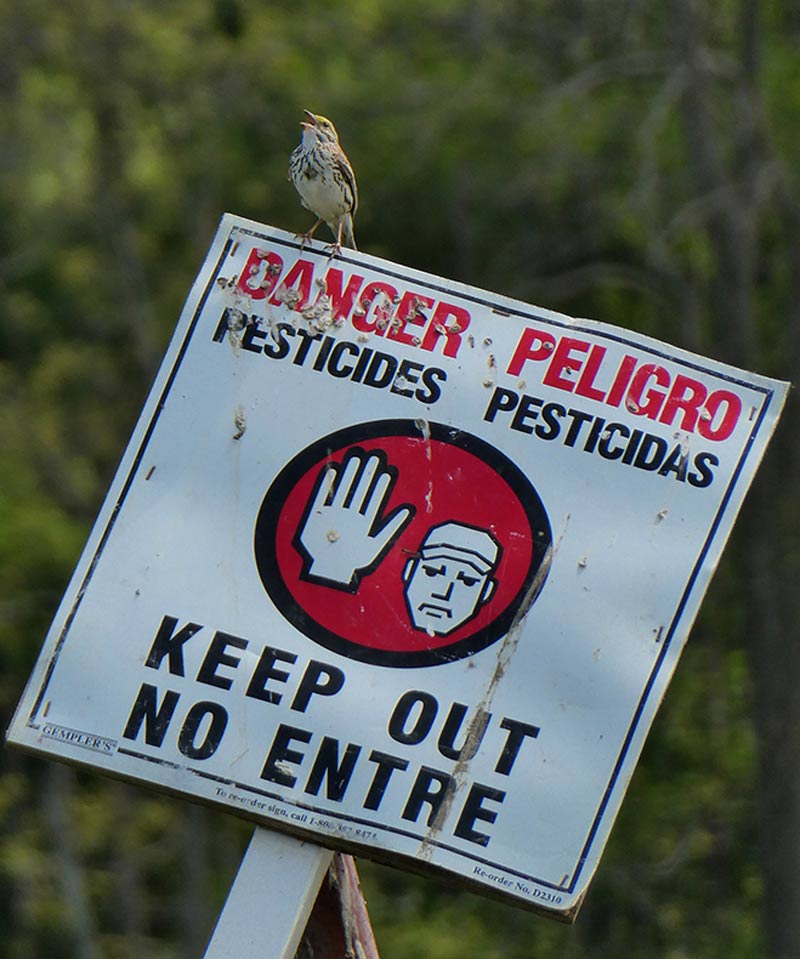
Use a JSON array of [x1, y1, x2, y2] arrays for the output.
[[0, 0, 800, 959]]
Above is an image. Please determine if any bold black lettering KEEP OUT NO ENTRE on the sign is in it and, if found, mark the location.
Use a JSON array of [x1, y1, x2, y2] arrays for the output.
[[122, 616, 540, 846]]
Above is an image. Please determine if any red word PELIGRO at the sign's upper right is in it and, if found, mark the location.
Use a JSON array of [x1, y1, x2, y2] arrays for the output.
[[506, 327, 742, 442]]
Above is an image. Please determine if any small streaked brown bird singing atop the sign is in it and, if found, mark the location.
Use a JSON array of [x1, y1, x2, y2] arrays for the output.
[[289, 110, 358, 253]]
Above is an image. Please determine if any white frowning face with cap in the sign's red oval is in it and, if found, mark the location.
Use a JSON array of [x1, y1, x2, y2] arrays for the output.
[[403, 523, 500, 636]]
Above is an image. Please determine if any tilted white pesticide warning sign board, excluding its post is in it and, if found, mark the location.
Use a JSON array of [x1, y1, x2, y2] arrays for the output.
[[9, 216, 786, 918]]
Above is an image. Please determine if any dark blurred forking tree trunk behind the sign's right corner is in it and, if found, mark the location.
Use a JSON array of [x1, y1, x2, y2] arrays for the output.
[[672, 0, 800, 959]]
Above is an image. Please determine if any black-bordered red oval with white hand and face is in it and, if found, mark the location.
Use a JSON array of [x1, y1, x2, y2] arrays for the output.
[[255, 420, 552, 667]]
